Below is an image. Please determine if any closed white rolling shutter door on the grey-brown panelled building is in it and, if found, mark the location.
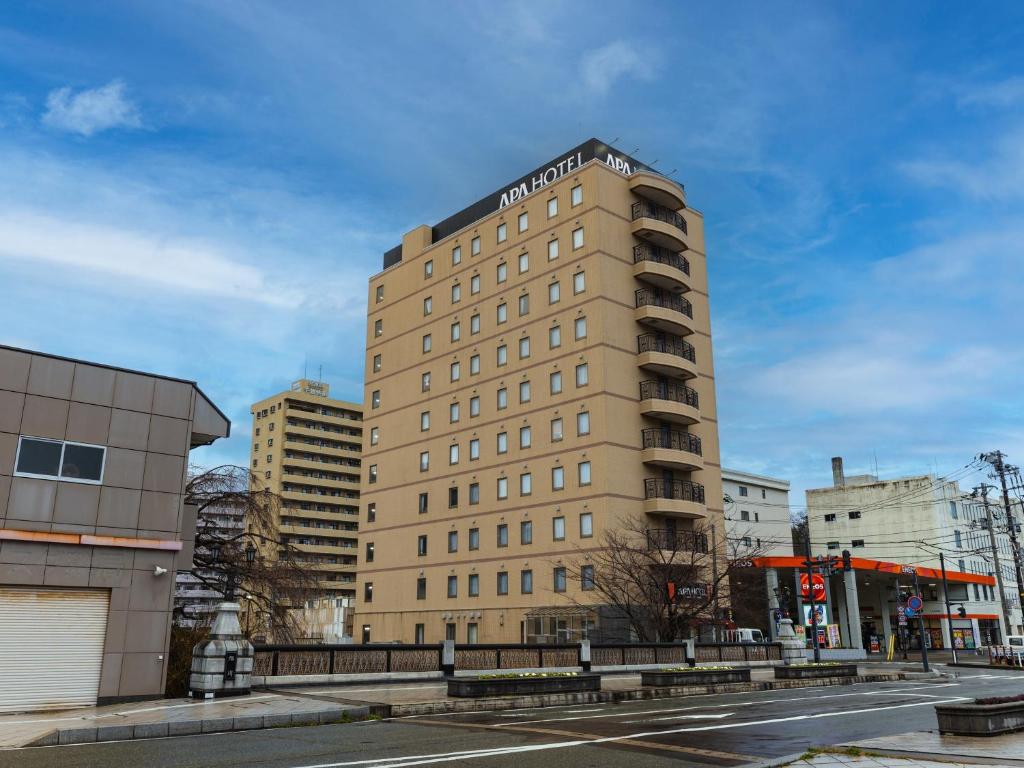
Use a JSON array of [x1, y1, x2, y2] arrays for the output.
[[0, 587, 110, 713]]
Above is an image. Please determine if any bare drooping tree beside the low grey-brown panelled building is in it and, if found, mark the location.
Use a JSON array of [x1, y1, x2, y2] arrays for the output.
[[185, 465, 317, 641]]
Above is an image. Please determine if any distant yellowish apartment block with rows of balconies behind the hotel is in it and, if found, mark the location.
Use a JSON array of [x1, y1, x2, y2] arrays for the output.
[[251, 379, 362, 606]]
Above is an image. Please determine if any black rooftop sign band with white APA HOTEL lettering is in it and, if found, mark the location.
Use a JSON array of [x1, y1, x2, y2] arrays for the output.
[[384, 138, 656, 269]]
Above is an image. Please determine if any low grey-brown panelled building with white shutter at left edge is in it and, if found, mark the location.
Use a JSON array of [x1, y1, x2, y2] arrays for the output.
[[0, 346, 230, 712]]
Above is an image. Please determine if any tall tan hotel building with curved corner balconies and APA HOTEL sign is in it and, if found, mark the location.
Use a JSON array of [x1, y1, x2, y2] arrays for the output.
[[354, 139, 725, 643]]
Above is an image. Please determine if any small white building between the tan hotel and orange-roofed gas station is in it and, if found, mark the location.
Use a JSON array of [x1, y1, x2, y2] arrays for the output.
[[722, 467, 793, 556]]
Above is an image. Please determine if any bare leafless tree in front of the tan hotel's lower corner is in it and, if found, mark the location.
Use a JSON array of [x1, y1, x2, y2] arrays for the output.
[[567, 516, 761, 642]]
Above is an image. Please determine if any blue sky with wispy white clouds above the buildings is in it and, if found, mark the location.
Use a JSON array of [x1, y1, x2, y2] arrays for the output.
[[0, 0, 1024, 506]]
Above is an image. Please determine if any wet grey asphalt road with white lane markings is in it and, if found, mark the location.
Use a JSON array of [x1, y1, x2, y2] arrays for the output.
[[0, 670, 1024, 768]]
